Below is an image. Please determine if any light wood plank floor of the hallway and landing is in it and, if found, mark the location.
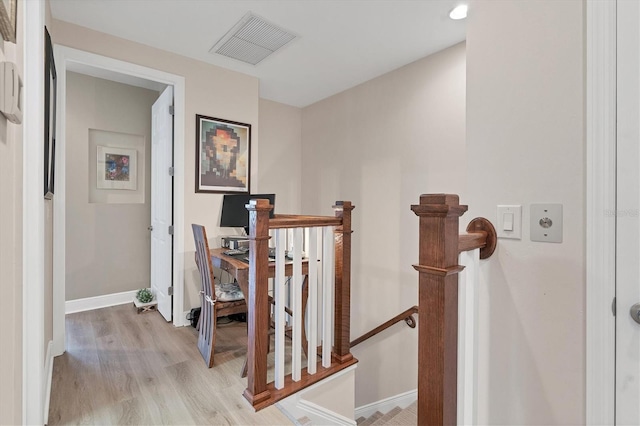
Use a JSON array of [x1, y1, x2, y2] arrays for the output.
[[48, 305, 292, 425]]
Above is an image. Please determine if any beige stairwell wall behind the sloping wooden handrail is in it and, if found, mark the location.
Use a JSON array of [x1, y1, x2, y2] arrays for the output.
[[302, 44, 466, 406]]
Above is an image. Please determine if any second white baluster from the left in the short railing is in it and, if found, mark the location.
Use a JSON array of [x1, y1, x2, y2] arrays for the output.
[[291, 228, 303, 382]]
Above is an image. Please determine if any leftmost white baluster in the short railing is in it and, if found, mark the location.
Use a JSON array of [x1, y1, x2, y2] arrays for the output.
[[273, 229, 286, 389]]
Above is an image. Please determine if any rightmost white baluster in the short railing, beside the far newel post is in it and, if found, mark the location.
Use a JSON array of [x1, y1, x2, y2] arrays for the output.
[[322, 226, 335, 368]]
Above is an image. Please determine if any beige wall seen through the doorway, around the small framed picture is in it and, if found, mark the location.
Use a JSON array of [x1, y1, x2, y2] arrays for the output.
[[60, 72, 158, 300]]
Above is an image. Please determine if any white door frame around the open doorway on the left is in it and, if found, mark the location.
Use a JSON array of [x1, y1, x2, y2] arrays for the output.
[[53, 45, 187, 356]]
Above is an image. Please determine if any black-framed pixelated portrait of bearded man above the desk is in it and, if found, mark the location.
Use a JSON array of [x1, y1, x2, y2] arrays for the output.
[[196, 115, 251, 194]]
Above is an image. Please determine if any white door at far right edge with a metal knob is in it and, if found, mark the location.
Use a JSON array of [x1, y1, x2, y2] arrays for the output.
[[616, 0, 640, 425]]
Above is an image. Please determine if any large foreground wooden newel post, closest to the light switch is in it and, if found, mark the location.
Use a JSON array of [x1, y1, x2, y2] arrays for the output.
[[411, 194, 467, 425]]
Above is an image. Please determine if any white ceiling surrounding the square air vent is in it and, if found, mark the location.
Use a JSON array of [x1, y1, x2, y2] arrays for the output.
[[50, 0, 465, 107]]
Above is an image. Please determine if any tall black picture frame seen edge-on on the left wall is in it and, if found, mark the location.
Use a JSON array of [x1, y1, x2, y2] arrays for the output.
[[44, 27, 58, 200]]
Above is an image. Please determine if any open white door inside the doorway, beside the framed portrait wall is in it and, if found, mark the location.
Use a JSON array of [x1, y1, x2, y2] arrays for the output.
[[150, 86, 173, 321]]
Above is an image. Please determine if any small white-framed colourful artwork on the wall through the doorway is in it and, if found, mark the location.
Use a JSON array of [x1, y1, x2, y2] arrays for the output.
[[96, 145, 138, 191]]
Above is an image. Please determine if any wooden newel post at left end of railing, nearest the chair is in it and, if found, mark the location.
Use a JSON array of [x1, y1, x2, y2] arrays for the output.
[[244, 199, 273, 406]]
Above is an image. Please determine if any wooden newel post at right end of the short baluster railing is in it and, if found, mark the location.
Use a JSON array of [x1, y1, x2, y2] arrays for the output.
[[333, 201, 355, 363]]
